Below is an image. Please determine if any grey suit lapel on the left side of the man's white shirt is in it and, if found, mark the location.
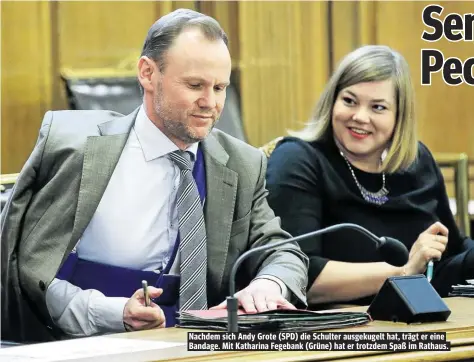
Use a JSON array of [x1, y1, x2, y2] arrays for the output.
[[68, 109, 138, 252]]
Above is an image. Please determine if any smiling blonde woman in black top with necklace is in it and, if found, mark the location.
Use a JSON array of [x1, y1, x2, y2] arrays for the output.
[[267, 46, 474, 304]]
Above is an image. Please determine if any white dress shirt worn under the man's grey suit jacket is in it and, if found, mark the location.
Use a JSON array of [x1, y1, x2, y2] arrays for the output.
[[46, 107, 286, 336]]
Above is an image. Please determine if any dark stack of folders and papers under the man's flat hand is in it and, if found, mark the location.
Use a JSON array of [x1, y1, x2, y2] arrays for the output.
[[178, 309, 370, 332]]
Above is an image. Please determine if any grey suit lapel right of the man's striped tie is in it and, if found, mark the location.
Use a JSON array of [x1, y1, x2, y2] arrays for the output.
[[203, 133, 238, 292]]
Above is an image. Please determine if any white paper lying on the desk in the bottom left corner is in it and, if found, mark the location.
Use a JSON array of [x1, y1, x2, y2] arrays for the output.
[[0, 336, 186, 362]]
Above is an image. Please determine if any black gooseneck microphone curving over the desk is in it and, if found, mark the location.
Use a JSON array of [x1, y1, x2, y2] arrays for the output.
[[226, 223, 409, 332]]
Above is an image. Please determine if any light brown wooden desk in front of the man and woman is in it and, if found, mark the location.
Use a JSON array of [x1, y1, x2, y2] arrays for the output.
[[105, 298, 474, 362]]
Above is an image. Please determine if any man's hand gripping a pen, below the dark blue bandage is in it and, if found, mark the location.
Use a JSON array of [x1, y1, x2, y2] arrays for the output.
[[123, 287, 166, 331]]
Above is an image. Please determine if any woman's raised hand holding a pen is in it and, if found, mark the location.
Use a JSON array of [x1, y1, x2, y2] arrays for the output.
[[404, 222, 448, 275]]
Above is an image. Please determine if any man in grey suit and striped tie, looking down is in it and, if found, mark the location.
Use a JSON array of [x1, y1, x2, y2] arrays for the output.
[[1, 9, 308, 341]]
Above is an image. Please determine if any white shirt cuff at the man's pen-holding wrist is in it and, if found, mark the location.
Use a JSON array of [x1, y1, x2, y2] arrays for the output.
[[90, 297, 128, 333]]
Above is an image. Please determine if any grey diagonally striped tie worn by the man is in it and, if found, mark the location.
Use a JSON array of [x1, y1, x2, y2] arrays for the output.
[[169, 151, 207, 310]]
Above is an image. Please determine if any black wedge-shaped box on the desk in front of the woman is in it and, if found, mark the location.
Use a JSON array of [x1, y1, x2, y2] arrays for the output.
[[367, 275, 451, 323]]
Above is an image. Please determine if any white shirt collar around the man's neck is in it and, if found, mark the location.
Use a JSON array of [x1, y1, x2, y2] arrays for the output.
[[134, 105, 199, 162]]
